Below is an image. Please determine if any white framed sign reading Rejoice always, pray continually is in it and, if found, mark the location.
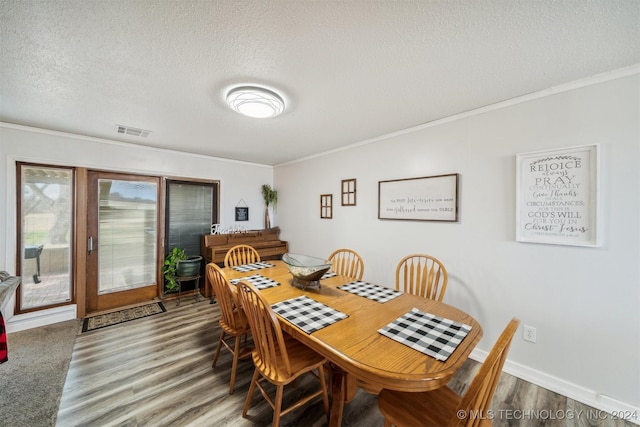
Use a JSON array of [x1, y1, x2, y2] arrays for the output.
[[516, 144, 600, 246]]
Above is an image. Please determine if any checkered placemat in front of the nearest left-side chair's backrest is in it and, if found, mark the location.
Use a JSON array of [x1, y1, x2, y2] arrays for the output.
[[271, 295, 349, 334]]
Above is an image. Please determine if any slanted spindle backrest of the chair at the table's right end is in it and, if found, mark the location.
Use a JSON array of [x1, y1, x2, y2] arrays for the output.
[[449, 317, 520, 427]]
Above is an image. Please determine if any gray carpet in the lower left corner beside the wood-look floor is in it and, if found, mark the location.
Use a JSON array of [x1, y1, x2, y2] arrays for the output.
[[0, 319, 82, 427]]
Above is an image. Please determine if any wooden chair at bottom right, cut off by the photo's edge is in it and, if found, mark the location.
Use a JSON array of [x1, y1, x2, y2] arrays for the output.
[[378, 318, 520, 427]]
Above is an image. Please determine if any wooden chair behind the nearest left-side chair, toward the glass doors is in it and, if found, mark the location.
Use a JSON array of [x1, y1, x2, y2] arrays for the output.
[[207, 263, 253, 394]]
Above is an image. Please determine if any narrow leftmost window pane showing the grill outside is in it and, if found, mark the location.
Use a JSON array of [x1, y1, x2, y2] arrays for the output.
[[18, 163, 74, 311]]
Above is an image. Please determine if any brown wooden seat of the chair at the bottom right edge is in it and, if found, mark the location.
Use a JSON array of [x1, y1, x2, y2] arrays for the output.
[[378, 386, 462, 427]]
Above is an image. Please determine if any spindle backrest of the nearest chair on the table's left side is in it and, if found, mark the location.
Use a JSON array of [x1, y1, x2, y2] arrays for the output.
[[238, 282, 291, 378]]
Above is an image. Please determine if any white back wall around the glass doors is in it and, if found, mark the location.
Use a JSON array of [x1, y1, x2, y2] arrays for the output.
[[0, 123, 277, 332]]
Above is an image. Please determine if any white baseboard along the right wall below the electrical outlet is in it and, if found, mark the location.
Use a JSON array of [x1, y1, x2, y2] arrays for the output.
[[469, 348, 640, 425]]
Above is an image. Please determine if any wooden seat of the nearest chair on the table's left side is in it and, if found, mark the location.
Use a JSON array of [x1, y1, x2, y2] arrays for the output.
[[253, 334, 326, 385]]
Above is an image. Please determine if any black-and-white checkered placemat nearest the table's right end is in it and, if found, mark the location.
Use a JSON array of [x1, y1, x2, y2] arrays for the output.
[[378, 308, 471, 362]]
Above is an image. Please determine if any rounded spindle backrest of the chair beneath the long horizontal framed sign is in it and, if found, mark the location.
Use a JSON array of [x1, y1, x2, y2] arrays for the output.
[[396, 254, 448, 302]]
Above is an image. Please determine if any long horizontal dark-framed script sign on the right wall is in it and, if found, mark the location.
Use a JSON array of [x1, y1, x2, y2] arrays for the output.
[[378, 173, 458, 222]]
